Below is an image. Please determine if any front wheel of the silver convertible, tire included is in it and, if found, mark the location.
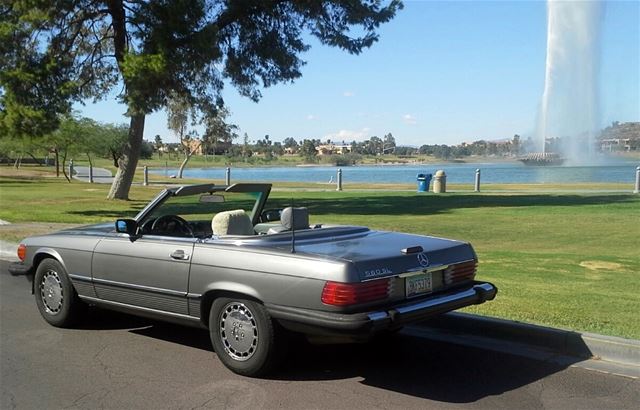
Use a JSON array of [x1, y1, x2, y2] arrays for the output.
[[34, 259, 84, 327]]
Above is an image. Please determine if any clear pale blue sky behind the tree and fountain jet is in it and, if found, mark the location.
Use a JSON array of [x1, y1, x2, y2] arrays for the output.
[[75, 0, 640, 146]]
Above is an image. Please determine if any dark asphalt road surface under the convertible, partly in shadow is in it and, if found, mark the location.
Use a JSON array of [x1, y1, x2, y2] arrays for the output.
[[0, 262, 640, 409]]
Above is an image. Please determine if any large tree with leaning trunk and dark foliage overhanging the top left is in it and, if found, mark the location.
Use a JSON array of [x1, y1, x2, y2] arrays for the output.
[[0, 0, 402, 199]]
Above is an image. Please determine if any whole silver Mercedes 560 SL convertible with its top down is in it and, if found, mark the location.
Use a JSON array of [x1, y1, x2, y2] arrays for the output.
[[10, 183, 497, 376]]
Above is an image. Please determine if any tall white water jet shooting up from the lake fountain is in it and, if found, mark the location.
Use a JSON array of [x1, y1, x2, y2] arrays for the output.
[[521, 0, 603, 165]]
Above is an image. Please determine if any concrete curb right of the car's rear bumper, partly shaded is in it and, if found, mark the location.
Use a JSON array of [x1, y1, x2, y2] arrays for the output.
[[420, 312, 640, 366]]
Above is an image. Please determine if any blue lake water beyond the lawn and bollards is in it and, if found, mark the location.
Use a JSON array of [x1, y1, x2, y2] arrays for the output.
[[155, 162, 638, 184]]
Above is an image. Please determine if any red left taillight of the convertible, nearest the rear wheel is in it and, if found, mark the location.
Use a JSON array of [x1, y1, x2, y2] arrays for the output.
[[322, 278, 390, 306]]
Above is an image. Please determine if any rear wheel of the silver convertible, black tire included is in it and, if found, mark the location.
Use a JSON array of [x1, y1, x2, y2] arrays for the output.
[[209, 298, 278, 377]]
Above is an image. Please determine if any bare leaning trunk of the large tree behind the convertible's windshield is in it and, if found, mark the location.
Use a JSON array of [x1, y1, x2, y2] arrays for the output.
[[107, 114, 145, 199]]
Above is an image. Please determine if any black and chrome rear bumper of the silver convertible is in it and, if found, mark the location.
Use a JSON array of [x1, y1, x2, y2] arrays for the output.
[[265, 282, 498, 335]]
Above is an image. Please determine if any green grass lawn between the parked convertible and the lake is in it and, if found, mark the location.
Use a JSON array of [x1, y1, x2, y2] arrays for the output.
[[0, 176, 640, 339]]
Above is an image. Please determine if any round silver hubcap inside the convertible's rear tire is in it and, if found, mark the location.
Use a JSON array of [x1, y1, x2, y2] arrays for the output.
[[219, 302, 258, 361]]
